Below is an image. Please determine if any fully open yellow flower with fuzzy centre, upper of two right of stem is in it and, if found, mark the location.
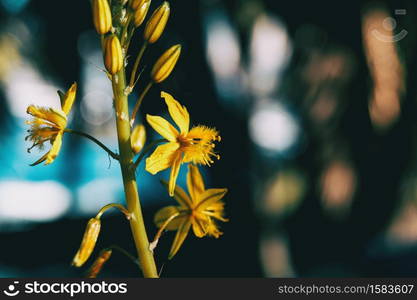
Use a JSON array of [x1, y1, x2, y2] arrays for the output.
[[146, 92, 221, 196]]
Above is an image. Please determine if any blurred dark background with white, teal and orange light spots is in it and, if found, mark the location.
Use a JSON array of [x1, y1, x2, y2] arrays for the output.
[[0, 0, 417, 277]]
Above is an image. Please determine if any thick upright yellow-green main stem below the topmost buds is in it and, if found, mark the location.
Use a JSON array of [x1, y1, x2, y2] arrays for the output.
[[112, 68, 158, 278]]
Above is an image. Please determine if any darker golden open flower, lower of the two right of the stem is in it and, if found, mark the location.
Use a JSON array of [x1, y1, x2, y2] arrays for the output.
[[154, 164, 228, 259]]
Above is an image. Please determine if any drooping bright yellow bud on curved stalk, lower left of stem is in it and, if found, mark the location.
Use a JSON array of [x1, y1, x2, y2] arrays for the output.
[[72, 218, 101, 267]]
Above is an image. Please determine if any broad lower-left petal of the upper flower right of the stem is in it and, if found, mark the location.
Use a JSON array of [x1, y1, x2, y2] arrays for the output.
[[145, 143, 179, 175]]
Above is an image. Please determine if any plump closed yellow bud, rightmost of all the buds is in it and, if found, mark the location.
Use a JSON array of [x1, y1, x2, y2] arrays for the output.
[[151, 44, 181, 83]]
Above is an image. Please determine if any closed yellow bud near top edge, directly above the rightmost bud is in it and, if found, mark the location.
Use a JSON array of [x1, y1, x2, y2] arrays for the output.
[[143, 1, 170, 44]]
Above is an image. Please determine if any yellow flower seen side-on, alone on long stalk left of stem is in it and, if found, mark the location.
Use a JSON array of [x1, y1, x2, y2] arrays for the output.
[[26, 83, 77, 166]]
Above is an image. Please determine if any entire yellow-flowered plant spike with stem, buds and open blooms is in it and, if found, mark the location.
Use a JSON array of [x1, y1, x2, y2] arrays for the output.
[[26, 0, 227, 277]]
